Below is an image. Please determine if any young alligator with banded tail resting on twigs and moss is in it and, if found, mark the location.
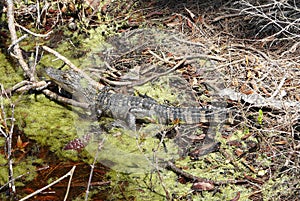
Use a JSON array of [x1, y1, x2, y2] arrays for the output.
[[45, 68, 225, 130]]
